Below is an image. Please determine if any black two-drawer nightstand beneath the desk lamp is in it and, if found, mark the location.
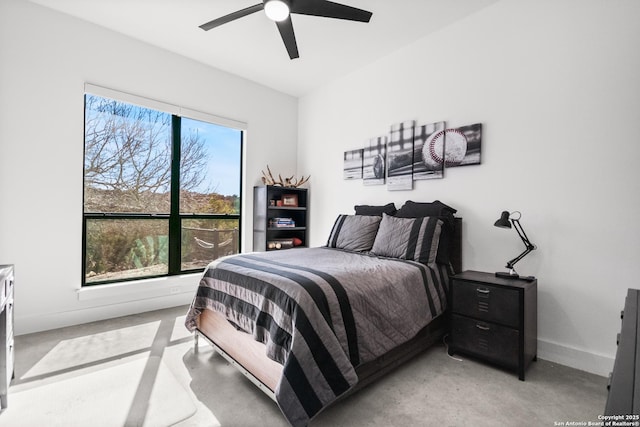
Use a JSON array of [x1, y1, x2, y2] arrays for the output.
[[449, 271, 538, 381]]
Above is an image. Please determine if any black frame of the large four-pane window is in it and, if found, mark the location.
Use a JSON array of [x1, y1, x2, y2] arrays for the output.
[[81, 91, 246, 288]]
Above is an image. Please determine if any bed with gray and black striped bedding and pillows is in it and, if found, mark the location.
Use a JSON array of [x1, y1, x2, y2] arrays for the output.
[[185, 201, 461, 427]]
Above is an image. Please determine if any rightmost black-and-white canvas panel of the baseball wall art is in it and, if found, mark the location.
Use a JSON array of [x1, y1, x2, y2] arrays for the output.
[[444, 123, 482, 168]]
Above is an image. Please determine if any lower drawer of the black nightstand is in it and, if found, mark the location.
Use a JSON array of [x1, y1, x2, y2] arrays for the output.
[[451, 314, 520, 368]]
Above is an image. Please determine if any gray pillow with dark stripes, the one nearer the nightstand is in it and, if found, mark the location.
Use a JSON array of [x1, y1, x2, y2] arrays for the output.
[[371, 214, 442, 265]]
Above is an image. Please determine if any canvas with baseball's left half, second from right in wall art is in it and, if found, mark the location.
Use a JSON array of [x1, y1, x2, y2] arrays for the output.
[[413, 122, 446, 180]]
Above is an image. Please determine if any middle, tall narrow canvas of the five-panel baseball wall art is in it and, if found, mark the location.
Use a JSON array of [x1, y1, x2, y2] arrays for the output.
[[387, 120, 415, 191]]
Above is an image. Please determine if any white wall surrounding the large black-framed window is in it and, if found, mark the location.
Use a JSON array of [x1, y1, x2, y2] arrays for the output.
[[0, 0, 297, 334]]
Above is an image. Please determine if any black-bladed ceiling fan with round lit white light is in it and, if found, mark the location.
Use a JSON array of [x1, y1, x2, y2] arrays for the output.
[[200, 0, 372, 59]]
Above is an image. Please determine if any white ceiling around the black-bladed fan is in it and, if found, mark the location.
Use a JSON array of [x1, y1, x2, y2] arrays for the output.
[[31, 0, 498, 96]]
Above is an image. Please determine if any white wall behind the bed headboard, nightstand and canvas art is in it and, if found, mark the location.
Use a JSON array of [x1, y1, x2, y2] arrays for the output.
[[298, 0, 640, 375]]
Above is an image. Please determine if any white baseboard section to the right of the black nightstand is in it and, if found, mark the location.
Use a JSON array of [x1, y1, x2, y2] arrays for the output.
[[538, 340, 614, 377]]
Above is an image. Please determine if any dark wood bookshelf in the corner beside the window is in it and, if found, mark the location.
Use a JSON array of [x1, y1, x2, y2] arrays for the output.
[[253, 185, 309, 251]]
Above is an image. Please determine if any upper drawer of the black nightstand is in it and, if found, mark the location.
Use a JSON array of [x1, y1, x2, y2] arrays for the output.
[[452, 279, 520, 328]]
